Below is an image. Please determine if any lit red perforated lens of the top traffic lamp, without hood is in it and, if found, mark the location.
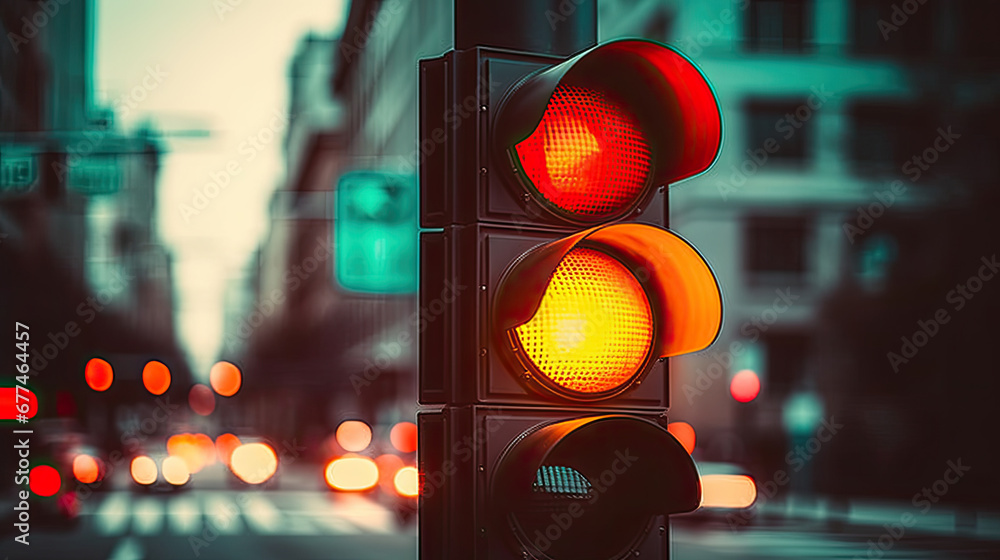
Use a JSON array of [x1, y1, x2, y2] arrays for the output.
[[514, 85, 651, 221]]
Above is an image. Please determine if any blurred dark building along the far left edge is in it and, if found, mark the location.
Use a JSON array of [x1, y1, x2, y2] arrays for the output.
[[0, 1, 189, 448]]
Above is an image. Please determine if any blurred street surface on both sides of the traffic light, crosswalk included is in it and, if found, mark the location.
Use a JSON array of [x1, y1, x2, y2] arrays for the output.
[[2, 489, 1000, 560]]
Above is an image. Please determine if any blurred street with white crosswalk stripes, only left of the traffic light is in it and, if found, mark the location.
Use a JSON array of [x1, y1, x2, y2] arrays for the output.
[[0, 462, 416, 560]]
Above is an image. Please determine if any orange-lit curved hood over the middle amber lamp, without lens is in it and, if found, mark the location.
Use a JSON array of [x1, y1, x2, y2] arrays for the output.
[[494, 223, 722, 366]]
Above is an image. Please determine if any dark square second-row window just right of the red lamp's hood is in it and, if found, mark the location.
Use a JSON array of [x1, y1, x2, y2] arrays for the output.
[[744, 99, 815, 166]]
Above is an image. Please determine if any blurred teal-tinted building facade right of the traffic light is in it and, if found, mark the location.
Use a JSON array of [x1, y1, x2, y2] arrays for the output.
[[599, 0, 998, 500]]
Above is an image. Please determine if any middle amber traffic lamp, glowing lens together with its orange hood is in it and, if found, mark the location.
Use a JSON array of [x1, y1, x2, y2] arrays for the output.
[[493, 223, 722, 400]]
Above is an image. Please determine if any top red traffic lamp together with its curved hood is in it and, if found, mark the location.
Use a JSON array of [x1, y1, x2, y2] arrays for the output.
[[494, 40, 722, 223]]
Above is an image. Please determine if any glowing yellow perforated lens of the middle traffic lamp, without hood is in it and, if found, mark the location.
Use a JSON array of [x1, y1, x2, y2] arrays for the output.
[[514, 248, 653, 393]]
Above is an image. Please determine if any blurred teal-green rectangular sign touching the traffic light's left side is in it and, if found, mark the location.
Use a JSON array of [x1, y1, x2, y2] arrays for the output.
[[333, 171, 419, 294]]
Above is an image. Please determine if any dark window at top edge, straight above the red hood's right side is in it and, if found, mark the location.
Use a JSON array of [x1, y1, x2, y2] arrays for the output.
[[746, 0, 812, 53]]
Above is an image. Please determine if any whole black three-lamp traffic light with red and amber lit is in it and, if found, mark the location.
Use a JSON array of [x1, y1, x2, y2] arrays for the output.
[[418, 40, 722, 560]]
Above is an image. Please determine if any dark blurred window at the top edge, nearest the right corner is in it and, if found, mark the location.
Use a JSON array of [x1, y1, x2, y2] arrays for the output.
[[853, 0, 937, 57]]
